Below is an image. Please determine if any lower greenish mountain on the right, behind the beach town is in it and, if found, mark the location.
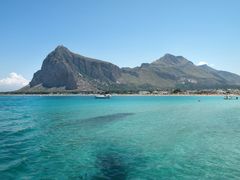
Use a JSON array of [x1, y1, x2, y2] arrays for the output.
[[121, 54, 240, 89]]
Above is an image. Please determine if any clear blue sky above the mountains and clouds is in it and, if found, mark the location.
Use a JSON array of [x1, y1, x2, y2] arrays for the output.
[[0, 0, 240, 90]]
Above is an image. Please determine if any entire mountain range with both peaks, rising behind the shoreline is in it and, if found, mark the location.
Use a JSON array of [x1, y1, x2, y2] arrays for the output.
[[19, 46, 240, 92]]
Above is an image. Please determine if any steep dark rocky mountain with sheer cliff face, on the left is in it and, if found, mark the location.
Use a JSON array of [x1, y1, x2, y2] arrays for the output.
[[30, 46, 121, 91]]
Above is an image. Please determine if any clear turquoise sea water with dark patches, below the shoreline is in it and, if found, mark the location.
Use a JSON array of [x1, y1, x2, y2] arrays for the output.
[[0, 96, 240, 179]]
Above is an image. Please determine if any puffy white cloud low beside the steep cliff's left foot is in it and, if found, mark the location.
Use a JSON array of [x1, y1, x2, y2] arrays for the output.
[[0, 72, 29, 91]]
